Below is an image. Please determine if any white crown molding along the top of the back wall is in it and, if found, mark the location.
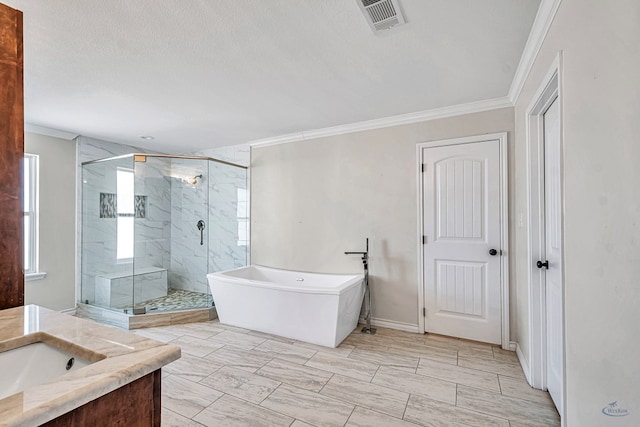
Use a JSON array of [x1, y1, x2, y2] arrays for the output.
[[248, 96, 513, 147]]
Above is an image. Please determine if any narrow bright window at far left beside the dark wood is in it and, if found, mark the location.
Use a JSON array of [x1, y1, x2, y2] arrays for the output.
[[22, 154, 38, 275]]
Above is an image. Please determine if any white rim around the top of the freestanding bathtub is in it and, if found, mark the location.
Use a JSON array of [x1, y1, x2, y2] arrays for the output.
[[207, 264, 364, 295]]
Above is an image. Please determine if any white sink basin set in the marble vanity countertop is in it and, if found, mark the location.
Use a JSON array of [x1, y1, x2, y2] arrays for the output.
[[0, 341, 93, 399]]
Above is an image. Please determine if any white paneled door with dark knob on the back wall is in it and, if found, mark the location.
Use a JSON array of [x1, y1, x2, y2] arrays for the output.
[[422, 140, 502, 344]]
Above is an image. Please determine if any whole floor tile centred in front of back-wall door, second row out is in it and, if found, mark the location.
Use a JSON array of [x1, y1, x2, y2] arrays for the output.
[[416, 359, 500, 393]]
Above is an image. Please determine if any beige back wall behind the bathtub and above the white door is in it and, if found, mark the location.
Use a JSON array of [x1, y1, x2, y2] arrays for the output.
[[251, 108, 513, 328]]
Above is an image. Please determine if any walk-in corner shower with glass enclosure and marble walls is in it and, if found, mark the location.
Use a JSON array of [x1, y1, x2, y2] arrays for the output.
[[80, 154, 249, 315]]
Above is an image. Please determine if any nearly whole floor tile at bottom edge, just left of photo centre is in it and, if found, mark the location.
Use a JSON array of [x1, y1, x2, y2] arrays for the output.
[[261, 384, 354, 427]]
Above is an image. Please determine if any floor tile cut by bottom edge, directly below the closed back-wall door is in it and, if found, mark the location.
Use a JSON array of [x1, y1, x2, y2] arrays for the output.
[[404, 394, 509, 427]]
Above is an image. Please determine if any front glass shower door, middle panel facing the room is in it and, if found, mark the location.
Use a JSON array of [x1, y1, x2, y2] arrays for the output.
[[134, 156, 211, 313]]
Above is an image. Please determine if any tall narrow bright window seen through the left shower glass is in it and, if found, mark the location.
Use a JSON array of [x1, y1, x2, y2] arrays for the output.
[[116, 168, 135, 262]]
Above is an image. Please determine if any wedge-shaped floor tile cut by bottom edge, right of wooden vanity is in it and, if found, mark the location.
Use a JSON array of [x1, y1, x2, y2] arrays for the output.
[[192, 395, 293, 427]]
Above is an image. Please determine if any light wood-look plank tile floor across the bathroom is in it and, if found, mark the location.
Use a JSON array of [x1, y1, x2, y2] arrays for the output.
[[135, 320, 560, 427]]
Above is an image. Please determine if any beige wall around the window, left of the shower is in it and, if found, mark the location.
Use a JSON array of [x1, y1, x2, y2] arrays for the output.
[[24, 133, 76, 310]]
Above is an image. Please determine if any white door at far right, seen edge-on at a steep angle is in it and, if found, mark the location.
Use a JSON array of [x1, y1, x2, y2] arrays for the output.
[[538, 99, 563, 413]]
